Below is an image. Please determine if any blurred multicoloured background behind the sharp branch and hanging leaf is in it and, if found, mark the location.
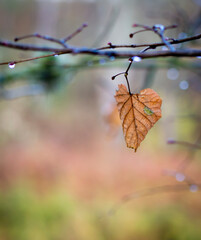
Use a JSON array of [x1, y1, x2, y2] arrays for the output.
[[0, 0, 201, 240]]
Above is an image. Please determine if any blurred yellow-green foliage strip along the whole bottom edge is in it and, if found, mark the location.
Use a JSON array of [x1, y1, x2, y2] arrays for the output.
[[0, 187, 201, 240]]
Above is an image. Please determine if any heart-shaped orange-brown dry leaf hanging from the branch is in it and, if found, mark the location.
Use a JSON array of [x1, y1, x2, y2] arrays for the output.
[[115, 84, 162, 152]]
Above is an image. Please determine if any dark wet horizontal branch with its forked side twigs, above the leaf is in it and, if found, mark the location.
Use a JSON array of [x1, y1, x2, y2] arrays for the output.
[[0, 23, 201, 65]]
